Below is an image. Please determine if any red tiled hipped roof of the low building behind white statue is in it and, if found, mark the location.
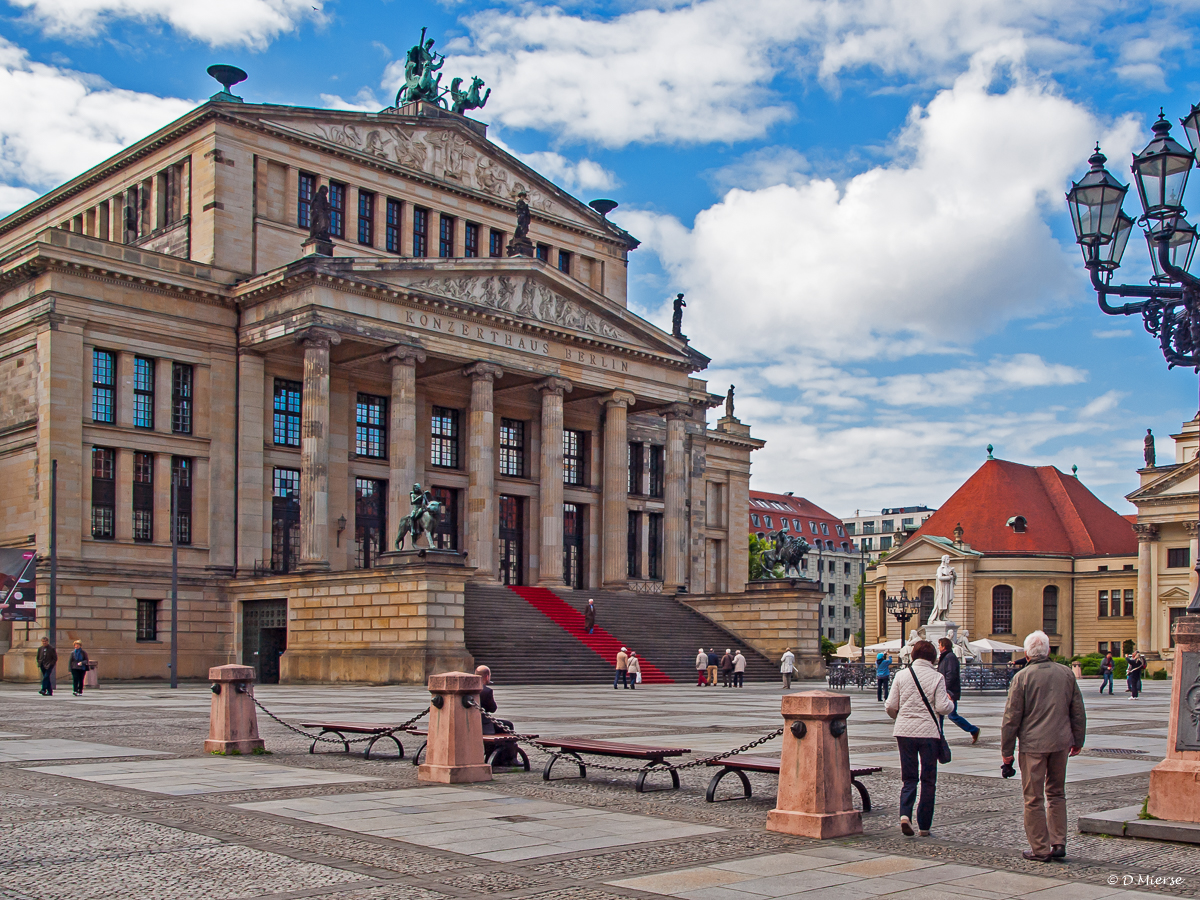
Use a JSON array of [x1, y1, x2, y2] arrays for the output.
[[917, 460, 1138, 557]]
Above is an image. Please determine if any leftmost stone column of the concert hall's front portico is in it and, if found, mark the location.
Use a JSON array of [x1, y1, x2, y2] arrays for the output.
[[298, 328, 341, 572]]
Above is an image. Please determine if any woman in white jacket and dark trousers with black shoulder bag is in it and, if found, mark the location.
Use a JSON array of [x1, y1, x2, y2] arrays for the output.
[[883, 641, 954, 838]]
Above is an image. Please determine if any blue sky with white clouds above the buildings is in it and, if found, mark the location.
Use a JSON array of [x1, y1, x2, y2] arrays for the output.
[[0, 0, 1200, 520]]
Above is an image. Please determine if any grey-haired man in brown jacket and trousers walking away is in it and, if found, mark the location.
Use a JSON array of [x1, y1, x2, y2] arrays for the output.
[[1000, 631, 1087, 863]]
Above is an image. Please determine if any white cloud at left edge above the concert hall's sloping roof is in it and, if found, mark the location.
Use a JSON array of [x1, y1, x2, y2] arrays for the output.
[[0, 37, 194, 199]]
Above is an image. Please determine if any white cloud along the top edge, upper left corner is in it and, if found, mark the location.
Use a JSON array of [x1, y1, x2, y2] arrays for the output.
[[8, 0, 325, 49]]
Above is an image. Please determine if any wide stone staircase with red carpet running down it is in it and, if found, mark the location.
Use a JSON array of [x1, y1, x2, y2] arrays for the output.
[[466, 584, 779, 684]]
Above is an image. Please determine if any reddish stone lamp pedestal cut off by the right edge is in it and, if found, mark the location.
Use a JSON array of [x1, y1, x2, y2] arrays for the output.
[[1146, 616, 1200, 822]]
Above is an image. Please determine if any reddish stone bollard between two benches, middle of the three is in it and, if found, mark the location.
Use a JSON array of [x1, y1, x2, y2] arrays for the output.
[[416, 672, 492, 785]]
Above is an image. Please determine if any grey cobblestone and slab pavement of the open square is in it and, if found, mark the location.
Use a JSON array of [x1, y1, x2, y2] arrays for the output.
[[0, 682, 1185, 900]]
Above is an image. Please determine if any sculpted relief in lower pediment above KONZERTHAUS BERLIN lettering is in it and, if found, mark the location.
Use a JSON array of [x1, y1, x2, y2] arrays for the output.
[[408, 275, 630, 341]]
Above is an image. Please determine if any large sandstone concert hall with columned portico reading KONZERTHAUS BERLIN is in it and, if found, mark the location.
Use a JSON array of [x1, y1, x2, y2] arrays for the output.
[[0, 84, 762, 682]]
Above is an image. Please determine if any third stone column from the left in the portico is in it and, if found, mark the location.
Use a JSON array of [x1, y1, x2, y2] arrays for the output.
[[462, 362, 504, 580]]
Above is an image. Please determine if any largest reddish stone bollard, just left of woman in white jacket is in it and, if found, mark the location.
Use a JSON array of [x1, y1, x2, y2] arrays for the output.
[[767, 691, 863, 840]]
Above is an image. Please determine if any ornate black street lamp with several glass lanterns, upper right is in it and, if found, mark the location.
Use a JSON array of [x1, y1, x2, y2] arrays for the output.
[[1070, 104, 1200, 613]]
